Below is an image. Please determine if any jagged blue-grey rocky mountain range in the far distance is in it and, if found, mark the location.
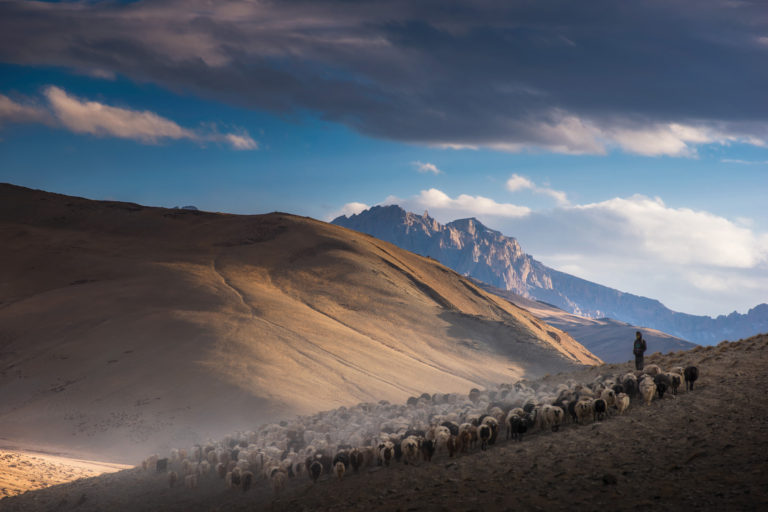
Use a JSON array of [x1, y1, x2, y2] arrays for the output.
[[332, 205, 768, 344]]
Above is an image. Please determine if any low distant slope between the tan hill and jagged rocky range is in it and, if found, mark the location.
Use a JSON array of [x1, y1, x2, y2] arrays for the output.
[[475, 281, 697, 363]]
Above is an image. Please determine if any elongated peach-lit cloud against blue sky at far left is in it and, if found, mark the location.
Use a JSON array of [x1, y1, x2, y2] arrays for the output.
[[0, 85, 258, 150]]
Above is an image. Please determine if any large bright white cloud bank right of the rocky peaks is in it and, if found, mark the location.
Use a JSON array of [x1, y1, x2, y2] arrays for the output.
[[492, 195, 768, 315]]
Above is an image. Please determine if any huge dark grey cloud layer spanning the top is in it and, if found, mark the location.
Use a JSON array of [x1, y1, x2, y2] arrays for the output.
[[0, 0, 768, 155]]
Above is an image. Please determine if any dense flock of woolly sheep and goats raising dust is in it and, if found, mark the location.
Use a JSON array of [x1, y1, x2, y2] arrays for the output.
[[142, 364, 699, 494]]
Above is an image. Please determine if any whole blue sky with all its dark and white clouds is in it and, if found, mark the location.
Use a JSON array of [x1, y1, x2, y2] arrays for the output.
[[0, 0, 768, 316]]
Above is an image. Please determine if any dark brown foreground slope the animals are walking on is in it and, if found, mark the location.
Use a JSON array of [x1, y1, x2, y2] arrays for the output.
[[0, 335, 768, 512]]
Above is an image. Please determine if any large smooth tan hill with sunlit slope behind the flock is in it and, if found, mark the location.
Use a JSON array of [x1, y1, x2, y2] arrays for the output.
[[0, 185, 600, 462]]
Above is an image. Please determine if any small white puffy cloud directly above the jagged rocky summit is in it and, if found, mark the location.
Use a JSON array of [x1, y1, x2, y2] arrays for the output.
[[381, 188, 531, 220]]
